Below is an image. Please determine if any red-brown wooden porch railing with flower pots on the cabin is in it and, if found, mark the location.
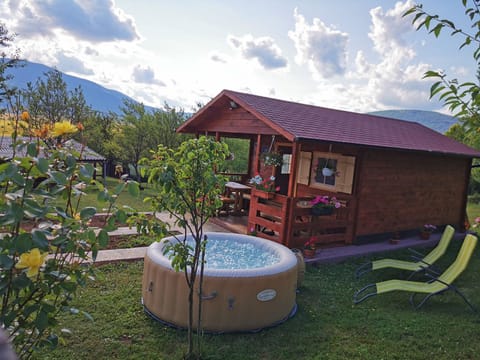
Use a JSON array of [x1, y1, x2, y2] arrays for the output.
[[248, 190, 353, 248]]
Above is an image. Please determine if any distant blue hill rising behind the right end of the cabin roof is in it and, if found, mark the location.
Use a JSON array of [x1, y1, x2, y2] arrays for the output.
[[369, 110, 458, 134]]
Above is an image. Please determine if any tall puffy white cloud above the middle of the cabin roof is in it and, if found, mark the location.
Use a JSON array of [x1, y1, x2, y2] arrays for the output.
[[288, 9, 348, 78]]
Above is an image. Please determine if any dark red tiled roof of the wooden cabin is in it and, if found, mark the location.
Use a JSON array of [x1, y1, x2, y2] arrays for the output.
[[224, 90, 480, 157]]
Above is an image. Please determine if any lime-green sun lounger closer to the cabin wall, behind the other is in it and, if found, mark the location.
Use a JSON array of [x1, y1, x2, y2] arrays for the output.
[[355, 225, 455, 279]]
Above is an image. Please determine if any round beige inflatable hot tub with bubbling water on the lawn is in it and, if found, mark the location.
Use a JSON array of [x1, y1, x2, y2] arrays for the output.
[[142, 232, 297, 332]]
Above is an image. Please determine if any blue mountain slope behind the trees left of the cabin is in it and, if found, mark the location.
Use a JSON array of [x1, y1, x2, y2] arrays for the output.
[[7, 61, 153, 114]]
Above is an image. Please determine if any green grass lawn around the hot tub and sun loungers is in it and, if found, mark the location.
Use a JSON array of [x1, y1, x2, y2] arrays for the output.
[[34, 236, 480, 360]]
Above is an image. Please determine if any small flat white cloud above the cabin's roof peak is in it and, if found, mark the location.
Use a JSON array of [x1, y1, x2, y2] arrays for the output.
[[228, 34, 288, 70]]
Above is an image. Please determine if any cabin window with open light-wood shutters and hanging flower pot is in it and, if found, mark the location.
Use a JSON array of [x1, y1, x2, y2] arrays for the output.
[[310, 152, 355, 194]]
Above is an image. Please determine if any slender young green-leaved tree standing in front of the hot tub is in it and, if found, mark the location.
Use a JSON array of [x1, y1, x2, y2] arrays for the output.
[[145, 136, 230, 359]]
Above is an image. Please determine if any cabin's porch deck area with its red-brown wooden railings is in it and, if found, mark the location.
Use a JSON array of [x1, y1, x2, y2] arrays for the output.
[[212, 184, 353, 248]]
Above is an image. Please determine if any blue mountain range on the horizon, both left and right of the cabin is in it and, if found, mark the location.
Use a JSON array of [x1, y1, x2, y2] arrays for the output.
[[7, 61, 457, 134]]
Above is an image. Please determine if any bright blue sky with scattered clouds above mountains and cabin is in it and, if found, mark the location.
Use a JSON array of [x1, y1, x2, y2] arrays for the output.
[[0, 0, 476, 113]]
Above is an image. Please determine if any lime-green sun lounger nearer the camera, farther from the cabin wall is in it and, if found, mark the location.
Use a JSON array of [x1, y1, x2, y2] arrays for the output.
[[353, 234, 478, 312]]
